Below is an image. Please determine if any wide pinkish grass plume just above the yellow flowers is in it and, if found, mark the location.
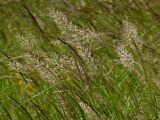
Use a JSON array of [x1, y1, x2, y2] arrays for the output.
[[9, 51, 76, 83]]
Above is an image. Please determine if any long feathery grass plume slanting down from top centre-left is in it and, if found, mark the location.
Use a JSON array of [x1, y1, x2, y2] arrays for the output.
[[48, 9, 102, 69]]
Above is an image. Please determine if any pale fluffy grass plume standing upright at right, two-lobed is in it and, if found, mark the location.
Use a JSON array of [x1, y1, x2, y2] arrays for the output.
[[116, 20, 143, 70]]
